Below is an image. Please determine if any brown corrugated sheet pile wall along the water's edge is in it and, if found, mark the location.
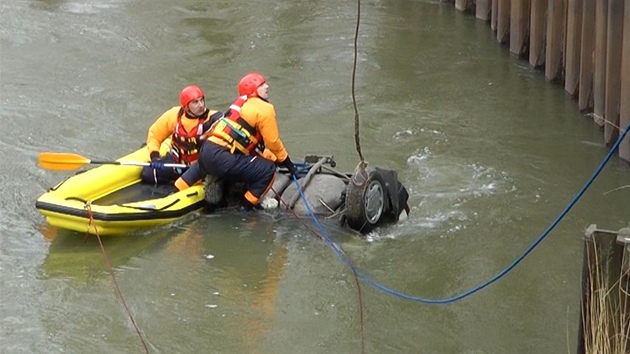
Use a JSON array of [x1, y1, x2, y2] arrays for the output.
[[444, 0, 630, 162]]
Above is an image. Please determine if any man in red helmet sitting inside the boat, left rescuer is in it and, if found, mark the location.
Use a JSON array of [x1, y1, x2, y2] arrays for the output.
[[142, 85, 223, 184]]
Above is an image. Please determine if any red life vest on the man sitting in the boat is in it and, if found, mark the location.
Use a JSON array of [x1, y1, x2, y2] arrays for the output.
[[171, 109, 206, 165]]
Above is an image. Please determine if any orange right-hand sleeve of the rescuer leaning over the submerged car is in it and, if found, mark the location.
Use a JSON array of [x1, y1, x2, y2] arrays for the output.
[[241, 98, 288, 162]]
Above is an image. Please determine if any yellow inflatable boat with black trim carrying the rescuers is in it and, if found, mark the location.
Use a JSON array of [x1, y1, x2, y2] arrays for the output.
[[35, 142, 206, 235]]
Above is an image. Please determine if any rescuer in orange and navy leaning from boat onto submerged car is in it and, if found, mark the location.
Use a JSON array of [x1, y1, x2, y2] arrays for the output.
[[175, 72, 295, 211]]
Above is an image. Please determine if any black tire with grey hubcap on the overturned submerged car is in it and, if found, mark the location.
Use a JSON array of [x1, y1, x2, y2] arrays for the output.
[[345, 170, 389, 233]]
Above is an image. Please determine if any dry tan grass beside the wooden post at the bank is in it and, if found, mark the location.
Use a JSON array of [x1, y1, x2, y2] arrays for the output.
[[582, 242, 630, 354]]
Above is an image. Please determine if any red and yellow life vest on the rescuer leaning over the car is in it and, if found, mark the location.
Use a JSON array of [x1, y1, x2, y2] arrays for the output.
[[210, 95, 265, 155]]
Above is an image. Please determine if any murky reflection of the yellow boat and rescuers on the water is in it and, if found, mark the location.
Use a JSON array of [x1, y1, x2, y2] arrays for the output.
[[39, 203, 360, 282]]
